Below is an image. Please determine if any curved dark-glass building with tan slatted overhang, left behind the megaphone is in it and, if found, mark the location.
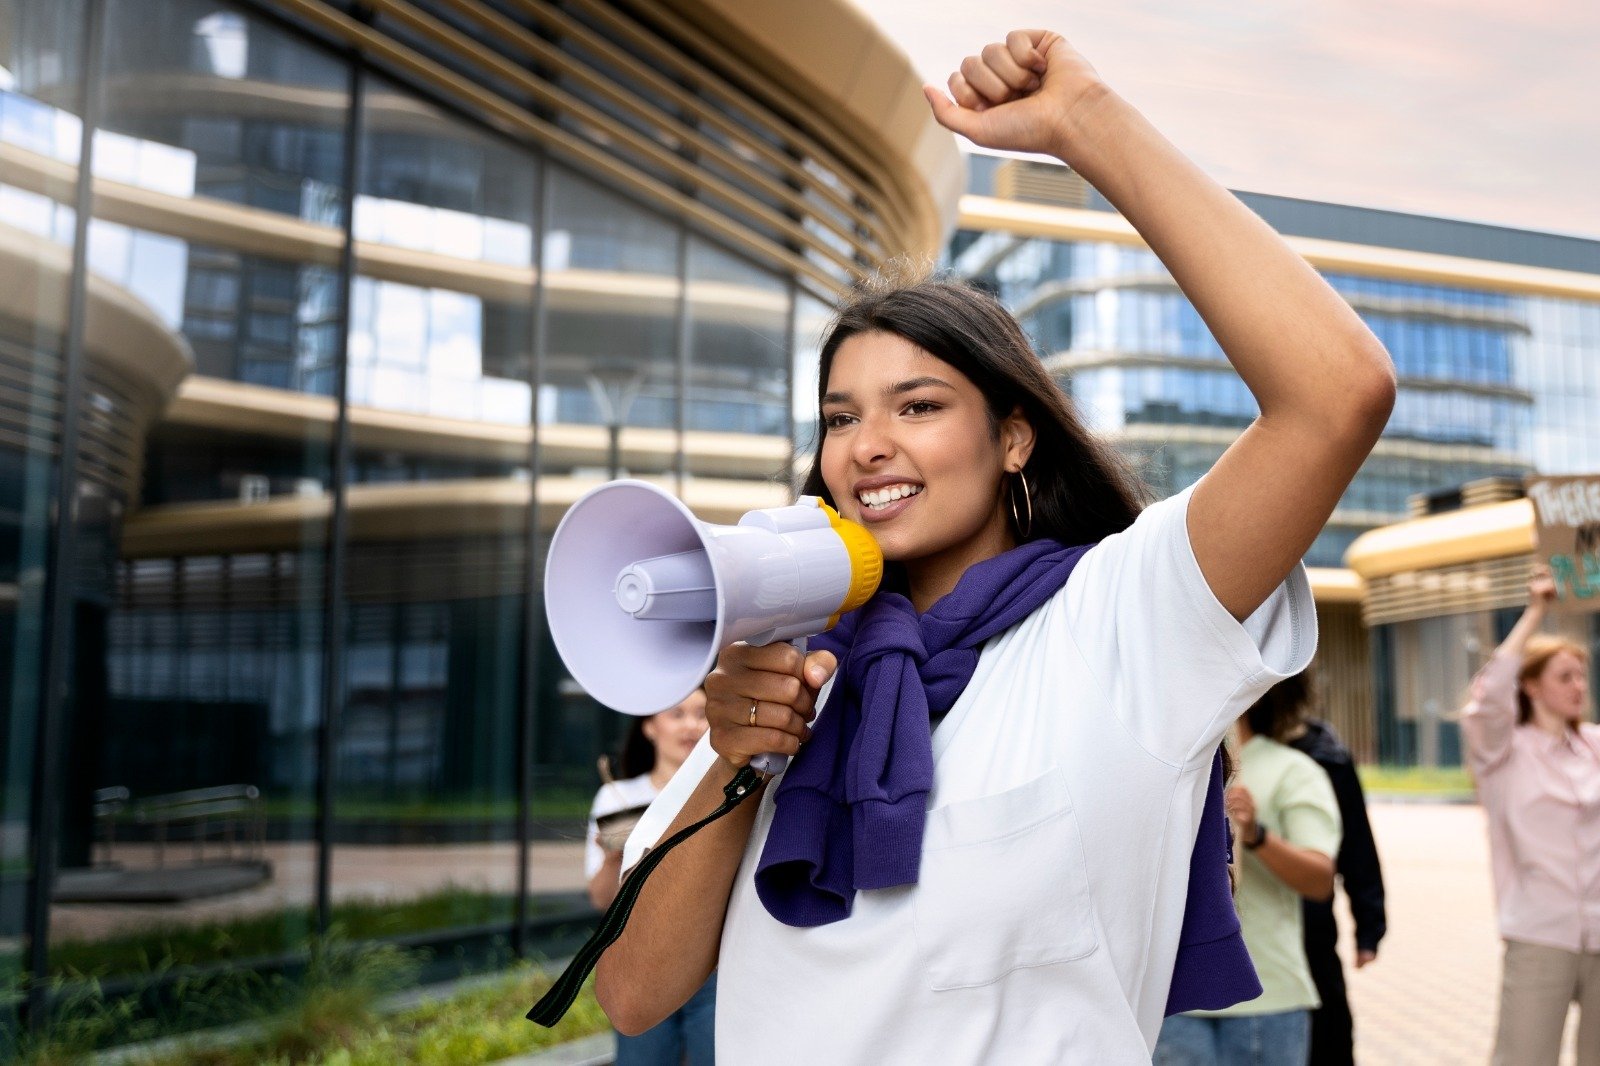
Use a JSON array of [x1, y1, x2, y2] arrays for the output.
[[0, 0, 962, 1043]]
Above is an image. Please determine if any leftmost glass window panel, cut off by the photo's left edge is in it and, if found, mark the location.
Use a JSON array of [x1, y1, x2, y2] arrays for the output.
[[0, 0, 83, 1024]]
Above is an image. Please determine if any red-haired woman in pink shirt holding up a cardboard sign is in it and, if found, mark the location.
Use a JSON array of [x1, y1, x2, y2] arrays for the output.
[[1461, 570, 1600, 1066]]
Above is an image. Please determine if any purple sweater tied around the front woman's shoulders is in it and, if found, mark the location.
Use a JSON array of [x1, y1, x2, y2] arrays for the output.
[[755, 539, 1261, 1015]]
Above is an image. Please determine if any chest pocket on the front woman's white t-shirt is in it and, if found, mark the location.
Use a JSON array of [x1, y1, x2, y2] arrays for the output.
[[914, 770, 1099, 991]]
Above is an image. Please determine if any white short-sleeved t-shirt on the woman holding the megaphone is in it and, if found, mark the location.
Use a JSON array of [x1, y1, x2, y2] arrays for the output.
[[622, 491, 1317, 1066]]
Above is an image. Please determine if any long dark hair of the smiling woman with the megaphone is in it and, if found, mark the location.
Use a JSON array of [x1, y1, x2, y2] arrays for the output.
[[802, 275, 1146, 544]]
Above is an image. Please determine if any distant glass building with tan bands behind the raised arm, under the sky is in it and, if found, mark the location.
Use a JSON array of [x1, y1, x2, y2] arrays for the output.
[[947, 155, 1600, 763]]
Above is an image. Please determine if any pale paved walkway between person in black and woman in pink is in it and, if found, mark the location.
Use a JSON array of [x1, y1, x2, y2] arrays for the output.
[[1339, 804, 1576, 1066]]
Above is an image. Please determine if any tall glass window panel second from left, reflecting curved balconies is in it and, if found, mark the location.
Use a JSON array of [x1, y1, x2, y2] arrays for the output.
[[51, 0, 347, 1024]]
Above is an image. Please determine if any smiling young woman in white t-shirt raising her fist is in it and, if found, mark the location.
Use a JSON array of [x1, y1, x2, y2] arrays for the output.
[[597, 30, 1394, 1063]]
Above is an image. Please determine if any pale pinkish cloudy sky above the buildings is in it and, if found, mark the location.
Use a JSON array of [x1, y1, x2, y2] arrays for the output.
[[854, 0, 1600, 238]]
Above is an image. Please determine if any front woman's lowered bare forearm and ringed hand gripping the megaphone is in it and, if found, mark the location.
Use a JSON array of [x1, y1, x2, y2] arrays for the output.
[[595, 643, 834, 1034]]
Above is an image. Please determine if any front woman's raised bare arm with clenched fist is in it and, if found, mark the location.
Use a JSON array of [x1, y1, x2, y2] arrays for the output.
[[925, 30, 1395, 618]]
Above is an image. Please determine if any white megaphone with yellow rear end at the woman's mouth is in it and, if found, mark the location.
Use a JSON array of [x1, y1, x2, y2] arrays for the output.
[[544, 480, 883, 768]]
